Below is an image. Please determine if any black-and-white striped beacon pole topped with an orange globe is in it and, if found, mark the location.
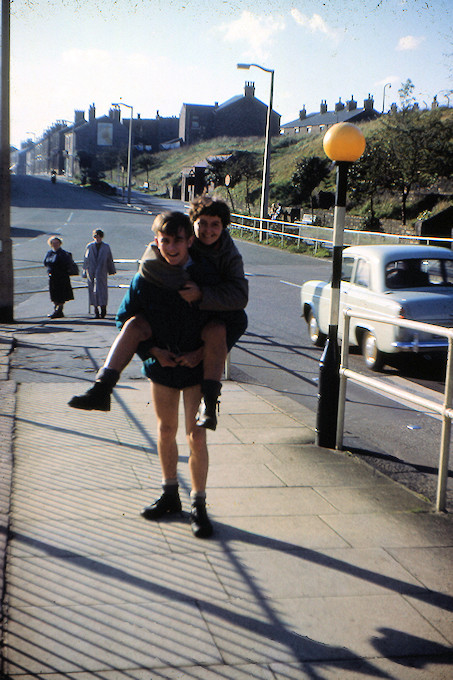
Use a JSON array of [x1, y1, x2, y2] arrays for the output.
[[316, 123, 365, 449]]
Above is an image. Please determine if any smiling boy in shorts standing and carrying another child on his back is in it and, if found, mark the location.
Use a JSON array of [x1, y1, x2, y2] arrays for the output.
[[115, 212, 218, 538]]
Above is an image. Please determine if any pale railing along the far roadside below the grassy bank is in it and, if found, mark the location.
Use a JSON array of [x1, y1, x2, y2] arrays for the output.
[[231, 213, 453, 249]]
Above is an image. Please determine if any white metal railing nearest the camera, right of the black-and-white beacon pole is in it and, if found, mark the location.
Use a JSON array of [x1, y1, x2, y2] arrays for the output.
[[335, 309, 453, 512]]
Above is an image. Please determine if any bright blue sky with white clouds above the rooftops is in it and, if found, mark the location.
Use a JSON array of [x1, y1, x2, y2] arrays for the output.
[[11, 0, 453, 147]]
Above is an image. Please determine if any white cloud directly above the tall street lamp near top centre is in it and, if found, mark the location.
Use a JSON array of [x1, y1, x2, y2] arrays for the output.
[[219, 11, 285, 59]]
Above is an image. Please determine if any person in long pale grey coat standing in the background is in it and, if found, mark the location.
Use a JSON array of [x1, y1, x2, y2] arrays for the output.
[[82, 229, 116, 319]]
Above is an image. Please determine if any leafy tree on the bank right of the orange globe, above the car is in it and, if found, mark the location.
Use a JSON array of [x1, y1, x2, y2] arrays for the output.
[[382, 109, 453, 224]]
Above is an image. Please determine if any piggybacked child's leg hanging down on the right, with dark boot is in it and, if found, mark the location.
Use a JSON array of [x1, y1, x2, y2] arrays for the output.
[[197, 321, 228, 430]]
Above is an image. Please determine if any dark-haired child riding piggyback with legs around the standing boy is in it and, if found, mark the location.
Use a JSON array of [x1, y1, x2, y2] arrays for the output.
[[69, 196, 248, 430]]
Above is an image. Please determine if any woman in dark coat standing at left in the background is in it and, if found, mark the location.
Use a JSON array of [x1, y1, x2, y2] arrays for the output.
[[44, 236, 74, 319]]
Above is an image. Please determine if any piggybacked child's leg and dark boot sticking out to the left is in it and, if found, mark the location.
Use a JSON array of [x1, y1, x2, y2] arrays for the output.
[[68, 314, 152, 411]]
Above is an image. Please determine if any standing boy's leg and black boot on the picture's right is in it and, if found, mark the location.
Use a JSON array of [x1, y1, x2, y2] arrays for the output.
[[183, 385, 213, 538]]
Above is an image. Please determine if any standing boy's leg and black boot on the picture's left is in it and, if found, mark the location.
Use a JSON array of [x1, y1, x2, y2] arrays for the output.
[[141, 383, 181, 520]]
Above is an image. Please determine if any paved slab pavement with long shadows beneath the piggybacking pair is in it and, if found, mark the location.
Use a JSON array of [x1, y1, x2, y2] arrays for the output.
[[0, 284, 453, 680]]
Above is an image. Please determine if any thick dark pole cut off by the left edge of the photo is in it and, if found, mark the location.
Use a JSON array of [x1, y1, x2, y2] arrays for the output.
[[0, 0, 14, 323]]
